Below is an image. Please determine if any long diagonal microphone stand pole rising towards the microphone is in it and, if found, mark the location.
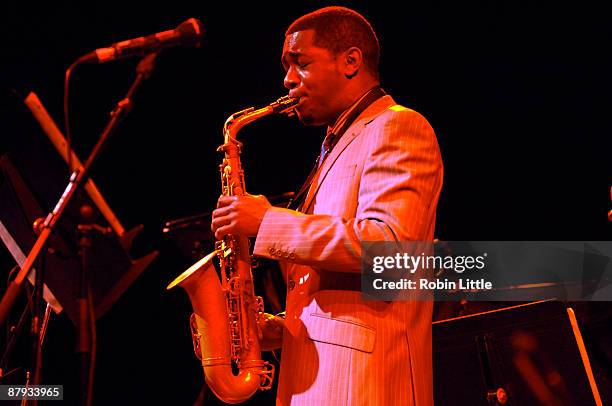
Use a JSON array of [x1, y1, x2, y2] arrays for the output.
[[0, 52, 158, 354]]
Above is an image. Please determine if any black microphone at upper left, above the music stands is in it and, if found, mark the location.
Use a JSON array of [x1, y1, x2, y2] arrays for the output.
[[77, 18, 204, 63]]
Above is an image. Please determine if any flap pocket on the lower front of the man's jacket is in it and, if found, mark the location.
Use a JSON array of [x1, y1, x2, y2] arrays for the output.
[[306, 313, 376, 353]]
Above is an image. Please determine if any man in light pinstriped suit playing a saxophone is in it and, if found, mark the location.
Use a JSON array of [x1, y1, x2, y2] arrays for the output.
[[212, 7, 443, 406]]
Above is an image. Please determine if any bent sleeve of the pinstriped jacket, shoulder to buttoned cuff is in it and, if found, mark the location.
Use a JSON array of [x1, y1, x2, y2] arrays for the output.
[[254, 106, 443, 272]]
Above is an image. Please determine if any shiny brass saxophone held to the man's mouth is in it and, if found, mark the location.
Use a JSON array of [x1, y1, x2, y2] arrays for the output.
[[167, 96, 299, 404]]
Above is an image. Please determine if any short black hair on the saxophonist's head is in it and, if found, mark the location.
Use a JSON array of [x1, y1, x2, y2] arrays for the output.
[[285, 7, 380, 79]]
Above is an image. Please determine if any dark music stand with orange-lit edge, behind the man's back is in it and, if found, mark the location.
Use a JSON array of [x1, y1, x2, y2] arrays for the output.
[[433, 301, 602, 406]]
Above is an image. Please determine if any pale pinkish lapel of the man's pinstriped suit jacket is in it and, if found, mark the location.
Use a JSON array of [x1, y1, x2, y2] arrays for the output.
[[302, 96, 395, 213]]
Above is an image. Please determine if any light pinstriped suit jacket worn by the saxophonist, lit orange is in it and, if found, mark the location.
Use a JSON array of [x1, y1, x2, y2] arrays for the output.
[[254, 96, 443, 406]]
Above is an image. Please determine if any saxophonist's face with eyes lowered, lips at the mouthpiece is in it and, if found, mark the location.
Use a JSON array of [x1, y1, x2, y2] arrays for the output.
[[282, 30, 347, 125]]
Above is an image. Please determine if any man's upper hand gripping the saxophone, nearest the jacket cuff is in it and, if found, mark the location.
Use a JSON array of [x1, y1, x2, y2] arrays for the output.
[[210, 194, 271, 240]]
